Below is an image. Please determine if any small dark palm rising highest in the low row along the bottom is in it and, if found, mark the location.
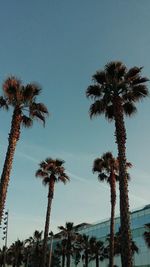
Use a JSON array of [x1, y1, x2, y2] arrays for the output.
[[58, 222, 75, 267]]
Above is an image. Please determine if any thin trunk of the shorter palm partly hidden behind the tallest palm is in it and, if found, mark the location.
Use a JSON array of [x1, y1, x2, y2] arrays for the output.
[[109, 170, 116, 267]]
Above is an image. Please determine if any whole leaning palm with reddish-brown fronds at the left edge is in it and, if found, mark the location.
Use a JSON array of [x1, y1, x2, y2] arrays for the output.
[[0, 77, 48, 222]]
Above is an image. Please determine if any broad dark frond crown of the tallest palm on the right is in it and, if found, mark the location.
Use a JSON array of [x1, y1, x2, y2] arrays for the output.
[[86, 61, 148, 120]]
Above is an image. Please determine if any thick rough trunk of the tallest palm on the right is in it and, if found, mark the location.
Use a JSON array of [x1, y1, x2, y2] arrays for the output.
[[114, 97, 133, 267]]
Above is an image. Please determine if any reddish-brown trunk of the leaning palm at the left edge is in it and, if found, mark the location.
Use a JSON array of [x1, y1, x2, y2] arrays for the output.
[[0, 108, 22, 223]]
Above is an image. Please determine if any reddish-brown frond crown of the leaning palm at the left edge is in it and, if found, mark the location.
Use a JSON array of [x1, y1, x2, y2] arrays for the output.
[[0, 76, 48, 127]]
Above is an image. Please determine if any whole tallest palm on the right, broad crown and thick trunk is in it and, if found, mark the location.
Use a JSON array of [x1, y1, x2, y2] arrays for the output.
[[86, 61, 148, 267]]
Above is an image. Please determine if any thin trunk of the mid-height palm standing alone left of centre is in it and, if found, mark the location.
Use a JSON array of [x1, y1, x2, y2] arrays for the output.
[[42, 179, 54, 267]]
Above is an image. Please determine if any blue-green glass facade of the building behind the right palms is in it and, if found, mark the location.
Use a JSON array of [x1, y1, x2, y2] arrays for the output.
[[71, 205, 150, 267]]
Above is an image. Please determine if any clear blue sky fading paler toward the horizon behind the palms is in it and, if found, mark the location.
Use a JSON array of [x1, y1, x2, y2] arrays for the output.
[[0, 0, 150, 245]]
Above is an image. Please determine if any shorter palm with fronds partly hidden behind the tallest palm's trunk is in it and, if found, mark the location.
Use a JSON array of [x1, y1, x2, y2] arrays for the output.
[[93, 152, 132, 267]]
